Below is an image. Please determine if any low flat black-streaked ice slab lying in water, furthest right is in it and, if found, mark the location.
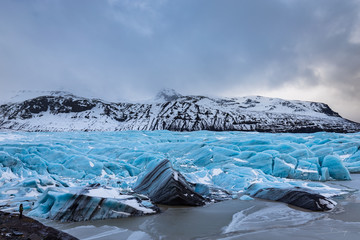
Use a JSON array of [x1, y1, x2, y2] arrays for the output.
[[248, 186, 336, 211]]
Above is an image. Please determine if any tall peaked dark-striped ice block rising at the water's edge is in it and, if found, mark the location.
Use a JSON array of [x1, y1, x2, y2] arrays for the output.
[[134, 159, 205, 206]]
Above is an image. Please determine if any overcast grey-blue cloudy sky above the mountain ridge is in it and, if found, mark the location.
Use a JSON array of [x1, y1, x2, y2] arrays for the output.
[[0, 0, 360, 122]]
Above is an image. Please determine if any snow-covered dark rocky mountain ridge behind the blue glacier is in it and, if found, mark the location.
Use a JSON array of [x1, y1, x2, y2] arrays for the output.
[[0, 90, 360, 132]]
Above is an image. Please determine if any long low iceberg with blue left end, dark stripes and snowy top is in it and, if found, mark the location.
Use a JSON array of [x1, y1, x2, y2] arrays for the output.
[[29, 185, 160, 222]]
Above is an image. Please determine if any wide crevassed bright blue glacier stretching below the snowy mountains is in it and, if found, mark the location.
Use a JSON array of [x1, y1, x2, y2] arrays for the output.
[[0, 131, 360, 221]]
